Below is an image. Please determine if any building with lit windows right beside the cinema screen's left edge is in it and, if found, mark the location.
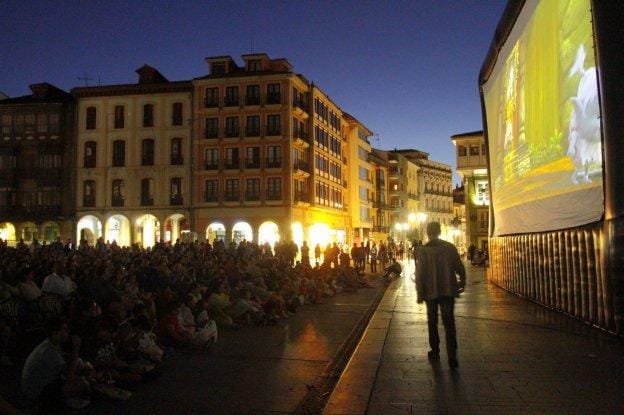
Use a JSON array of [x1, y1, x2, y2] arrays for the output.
[[451, 131, 490, 249]]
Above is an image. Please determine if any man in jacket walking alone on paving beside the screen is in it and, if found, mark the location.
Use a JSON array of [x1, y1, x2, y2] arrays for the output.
[[416, 222, 466, 369]]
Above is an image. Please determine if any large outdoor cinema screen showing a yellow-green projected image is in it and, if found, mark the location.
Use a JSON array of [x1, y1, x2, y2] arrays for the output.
[[482, 0, 604, 235]]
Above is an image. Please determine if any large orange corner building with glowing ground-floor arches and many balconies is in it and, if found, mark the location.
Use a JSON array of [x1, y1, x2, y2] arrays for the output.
[[192, 53, 350, 246]]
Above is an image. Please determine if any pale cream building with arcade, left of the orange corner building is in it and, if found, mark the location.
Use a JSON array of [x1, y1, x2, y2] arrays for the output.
[[72, 65, 193, 247]]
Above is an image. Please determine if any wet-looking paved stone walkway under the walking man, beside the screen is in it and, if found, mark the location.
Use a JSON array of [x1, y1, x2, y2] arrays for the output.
[[324, 264, 624, 415]]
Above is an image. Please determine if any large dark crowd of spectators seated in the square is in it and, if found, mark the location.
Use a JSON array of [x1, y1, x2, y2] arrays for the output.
[[0, 239, 367, 410]]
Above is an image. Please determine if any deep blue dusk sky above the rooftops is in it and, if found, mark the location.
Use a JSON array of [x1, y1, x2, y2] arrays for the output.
[[0, 0, 506, 182]]
